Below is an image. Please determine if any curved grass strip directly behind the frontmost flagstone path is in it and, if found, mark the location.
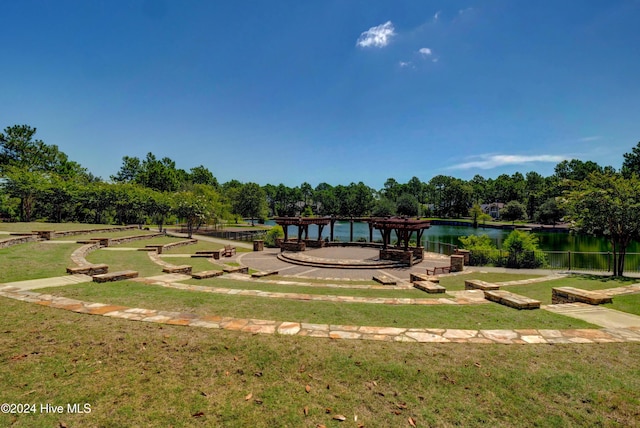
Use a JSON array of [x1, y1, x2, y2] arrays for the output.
[[46, 281, 595, 329]]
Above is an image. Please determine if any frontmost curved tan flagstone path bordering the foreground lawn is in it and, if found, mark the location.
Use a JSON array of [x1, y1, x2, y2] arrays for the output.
[[0, 283, 640, 344]]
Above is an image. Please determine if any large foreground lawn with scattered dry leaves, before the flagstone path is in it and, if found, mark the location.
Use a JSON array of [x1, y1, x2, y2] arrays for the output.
[[0, 298, 640, 428]]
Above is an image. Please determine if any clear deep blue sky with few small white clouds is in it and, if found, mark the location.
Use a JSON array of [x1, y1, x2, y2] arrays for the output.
[[0, 0, 640, 188]]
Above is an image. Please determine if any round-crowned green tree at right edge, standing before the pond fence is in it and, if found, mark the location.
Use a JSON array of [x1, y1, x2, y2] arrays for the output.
[[566, 172, 640, 276]]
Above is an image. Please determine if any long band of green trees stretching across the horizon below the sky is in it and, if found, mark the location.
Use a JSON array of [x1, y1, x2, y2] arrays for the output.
[[0, 125, 640, 274]]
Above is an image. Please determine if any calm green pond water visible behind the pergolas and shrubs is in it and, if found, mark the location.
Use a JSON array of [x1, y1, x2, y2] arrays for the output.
[[266, 220, 640, 253]]
